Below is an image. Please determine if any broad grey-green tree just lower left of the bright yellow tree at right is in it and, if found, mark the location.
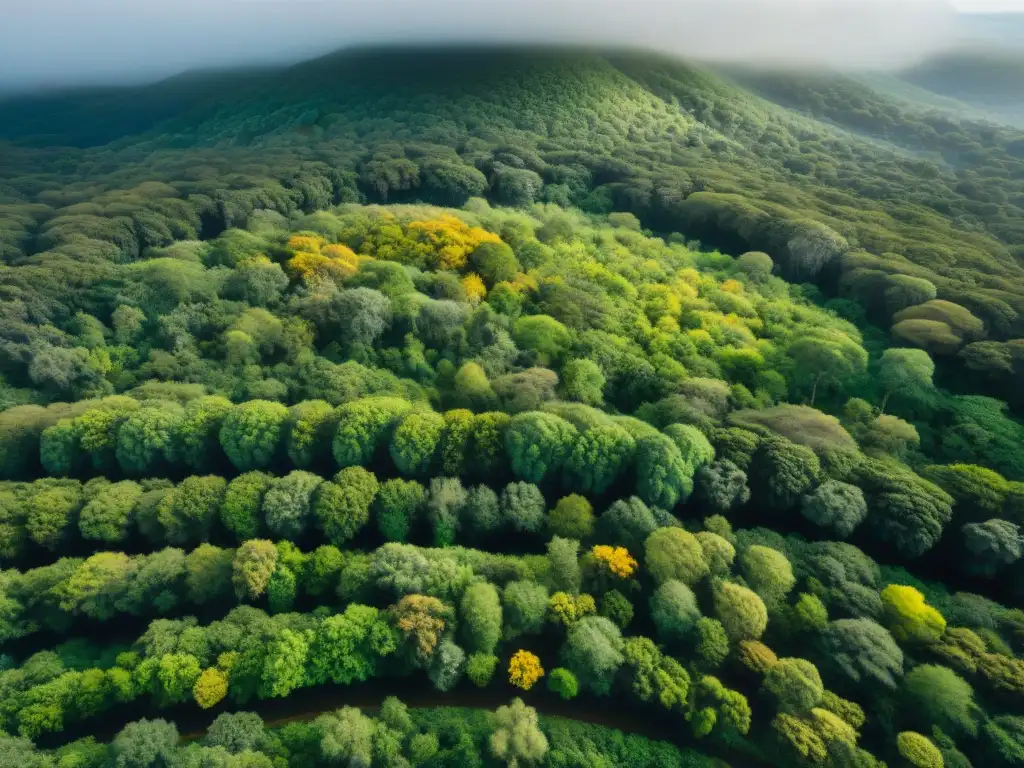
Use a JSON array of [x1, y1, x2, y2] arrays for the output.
[[818, 618, 903, 688]]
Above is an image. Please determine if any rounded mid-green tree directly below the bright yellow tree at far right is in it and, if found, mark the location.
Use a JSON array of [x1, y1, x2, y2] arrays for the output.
[[902, 664, 982, 736]]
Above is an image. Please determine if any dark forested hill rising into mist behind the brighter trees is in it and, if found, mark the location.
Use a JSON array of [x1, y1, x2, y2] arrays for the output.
[[0, 49, 1024, 366]]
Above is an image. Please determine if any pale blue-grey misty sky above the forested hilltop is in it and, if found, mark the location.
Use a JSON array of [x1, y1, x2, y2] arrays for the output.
[[0, 0, 1024, 88]]
